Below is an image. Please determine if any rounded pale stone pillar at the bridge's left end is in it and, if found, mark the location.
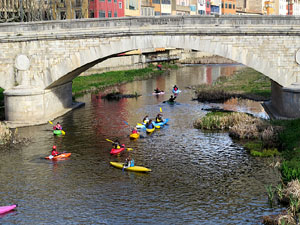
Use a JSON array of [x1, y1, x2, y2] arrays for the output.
[[4, 82, 72, 125]]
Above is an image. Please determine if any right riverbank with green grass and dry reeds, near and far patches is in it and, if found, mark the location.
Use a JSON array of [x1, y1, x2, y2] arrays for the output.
[[194, 69, 300, 224]]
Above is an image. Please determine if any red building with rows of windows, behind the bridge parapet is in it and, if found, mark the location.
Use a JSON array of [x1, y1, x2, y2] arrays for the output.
[[89, 0, 125, 18]]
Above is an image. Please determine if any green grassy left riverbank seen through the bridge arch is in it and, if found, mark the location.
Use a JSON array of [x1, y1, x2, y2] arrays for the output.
[[72, 63, 177, 96]]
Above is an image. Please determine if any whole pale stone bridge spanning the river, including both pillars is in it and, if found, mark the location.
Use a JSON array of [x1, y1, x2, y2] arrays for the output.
[[0, 16, 300, 124]]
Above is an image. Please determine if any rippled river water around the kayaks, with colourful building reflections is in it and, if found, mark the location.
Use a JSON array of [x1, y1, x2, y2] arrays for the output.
[[0, 65, 282, 224]]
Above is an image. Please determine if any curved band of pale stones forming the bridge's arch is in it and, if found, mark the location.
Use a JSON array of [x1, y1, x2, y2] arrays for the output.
[[45, 35, 282, 89]]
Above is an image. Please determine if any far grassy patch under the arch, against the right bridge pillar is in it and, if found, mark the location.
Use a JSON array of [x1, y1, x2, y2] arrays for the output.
[[195, 68, 271, 101]]
